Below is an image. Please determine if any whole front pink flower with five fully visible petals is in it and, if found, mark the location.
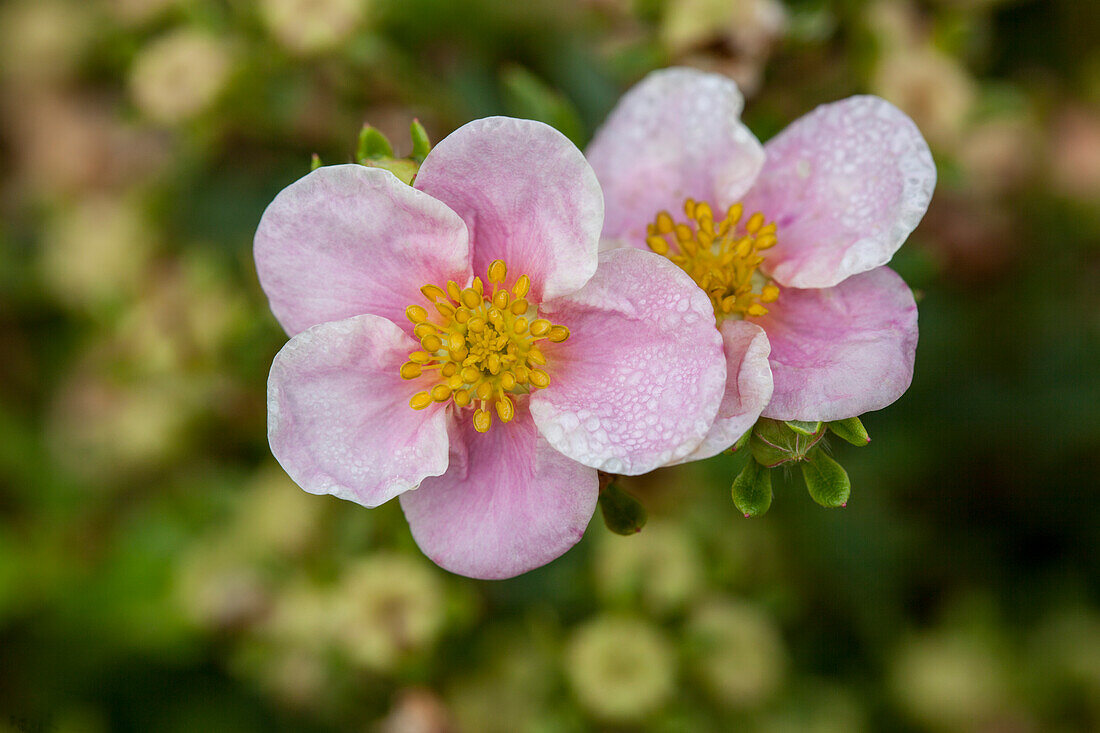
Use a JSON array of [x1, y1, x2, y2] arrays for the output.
[[255, 118, 725, 578]]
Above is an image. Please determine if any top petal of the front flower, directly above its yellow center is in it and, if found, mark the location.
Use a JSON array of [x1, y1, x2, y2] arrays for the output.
[[414, 117, 604, 303]]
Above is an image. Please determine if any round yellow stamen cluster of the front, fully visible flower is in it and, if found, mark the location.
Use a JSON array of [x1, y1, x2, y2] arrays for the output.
[[400, 260, 569, 433]]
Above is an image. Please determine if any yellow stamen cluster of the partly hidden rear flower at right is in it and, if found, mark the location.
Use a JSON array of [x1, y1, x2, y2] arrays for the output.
[[646, 198, 779, 322]]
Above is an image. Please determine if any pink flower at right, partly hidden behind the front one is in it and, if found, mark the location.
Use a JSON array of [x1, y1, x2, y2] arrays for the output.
[[587, 68, 936, 440]]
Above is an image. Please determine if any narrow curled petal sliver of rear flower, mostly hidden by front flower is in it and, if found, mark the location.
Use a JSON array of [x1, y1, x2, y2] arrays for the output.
[[677, 320, 772, 463]]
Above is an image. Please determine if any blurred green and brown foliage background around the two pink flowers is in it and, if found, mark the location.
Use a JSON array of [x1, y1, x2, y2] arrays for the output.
[[0, 0, 1100, 733]]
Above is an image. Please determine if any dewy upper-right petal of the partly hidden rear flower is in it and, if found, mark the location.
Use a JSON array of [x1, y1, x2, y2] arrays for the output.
[[745, 97, 936, 287]]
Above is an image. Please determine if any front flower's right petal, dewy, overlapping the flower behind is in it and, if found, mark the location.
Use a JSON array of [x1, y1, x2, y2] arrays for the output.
[[531, 248, 726, 474]]
